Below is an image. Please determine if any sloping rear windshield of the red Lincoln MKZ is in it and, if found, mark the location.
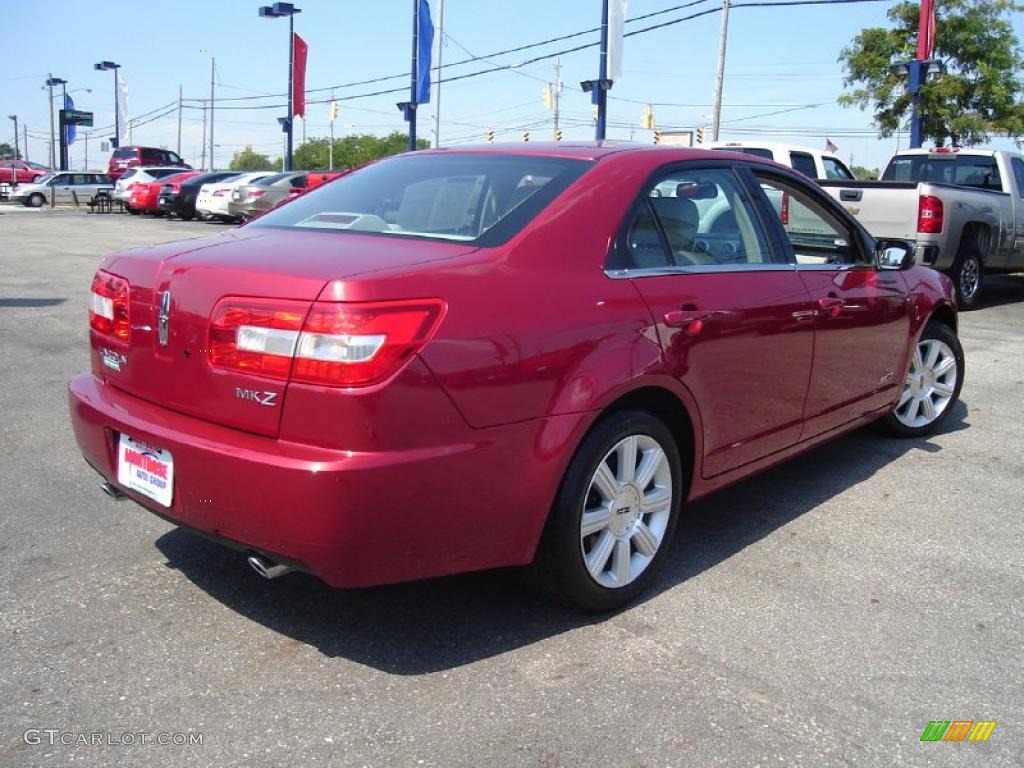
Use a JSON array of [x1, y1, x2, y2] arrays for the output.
[[252, 153, 592, 245]]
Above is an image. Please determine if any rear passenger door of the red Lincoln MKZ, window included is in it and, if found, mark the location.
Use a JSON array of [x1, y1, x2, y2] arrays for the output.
[[612, 164, 814, 477]]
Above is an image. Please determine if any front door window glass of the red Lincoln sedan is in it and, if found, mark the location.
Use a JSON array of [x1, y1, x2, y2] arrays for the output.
[[755, 172, 868, 268]]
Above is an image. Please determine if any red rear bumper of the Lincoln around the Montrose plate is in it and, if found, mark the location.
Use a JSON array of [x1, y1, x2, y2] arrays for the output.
[[69, 374, 586, 587]]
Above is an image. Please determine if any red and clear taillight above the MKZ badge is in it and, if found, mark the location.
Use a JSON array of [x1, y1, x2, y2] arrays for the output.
[[209, 299, 444, 387]]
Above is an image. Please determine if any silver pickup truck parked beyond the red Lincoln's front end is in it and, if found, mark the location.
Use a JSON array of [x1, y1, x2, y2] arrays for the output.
[[819, 150, 1024, 309]]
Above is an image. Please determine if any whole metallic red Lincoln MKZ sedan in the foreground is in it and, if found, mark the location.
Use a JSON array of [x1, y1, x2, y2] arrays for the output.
[[70, 144, 964, 609]]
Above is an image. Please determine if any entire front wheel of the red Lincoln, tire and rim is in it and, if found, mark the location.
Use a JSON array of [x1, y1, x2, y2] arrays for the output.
[[883, 323, 964, 437]]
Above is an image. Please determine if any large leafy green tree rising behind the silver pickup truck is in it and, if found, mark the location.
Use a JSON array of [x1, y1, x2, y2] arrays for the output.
[[839, 0, 1024, 146]]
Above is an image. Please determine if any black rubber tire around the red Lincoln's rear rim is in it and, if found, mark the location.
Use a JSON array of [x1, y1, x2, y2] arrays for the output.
[[527, 411, 684, 611]]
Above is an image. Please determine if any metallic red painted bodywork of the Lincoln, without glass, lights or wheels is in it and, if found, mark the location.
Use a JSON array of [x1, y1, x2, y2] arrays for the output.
[[69, 144, 952, 586]]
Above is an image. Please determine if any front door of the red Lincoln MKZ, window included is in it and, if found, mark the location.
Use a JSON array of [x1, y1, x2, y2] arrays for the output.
[[754, 168, 910, 438]]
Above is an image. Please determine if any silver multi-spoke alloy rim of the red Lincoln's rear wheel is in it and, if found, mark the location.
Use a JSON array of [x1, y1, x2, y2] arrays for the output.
[[580, 434, 673, 589]]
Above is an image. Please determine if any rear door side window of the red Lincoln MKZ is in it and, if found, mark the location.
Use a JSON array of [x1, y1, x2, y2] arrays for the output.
[[610, 168, 773, 271]]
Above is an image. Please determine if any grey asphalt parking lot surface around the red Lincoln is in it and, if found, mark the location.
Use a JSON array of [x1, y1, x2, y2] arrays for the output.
[[0, 206, 1024, 768]]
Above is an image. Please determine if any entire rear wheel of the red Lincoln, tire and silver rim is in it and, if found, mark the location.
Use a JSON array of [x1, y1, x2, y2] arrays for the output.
[[529, 411, 683, 610]]
